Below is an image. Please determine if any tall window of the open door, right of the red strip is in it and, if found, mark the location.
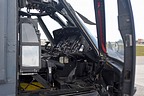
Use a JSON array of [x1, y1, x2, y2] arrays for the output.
[[105, 0, 124, 61]]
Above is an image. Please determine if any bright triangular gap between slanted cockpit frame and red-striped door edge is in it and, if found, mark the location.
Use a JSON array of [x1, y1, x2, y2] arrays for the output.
[[67, 0, 98, 48]]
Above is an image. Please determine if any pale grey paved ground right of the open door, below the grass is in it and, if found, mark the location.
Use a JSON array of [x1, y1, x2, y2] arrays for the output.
[[134, 56, 144, 96]]
